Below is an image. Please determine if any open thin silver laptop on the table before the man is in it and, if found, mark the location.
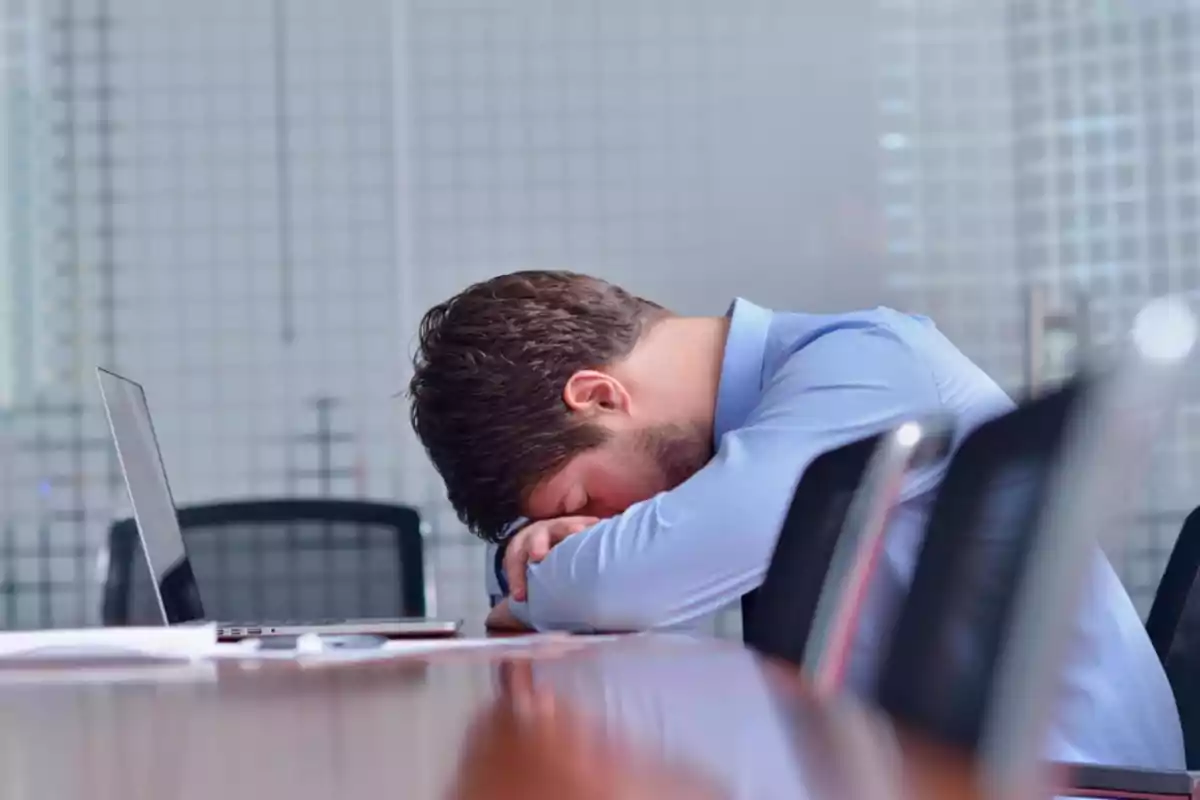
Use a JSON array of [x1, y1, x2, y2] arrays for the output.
[[96, 367, 462, 640]]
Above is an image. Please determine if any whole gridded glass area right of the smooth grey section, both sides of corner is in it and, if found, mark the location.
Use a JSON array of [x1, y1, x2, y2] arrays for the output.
[[876, 0, 1200, 610]]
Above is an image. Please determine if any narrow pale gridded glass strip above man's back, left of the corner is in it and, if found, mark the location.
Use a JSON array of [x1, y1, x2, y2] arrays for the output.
[[875, 0, 1024, 389]]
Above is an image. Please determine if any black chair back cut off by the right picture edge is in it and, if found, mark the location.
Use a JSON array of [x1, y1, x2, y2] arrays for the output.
[[1146, 507, 1200, 770]]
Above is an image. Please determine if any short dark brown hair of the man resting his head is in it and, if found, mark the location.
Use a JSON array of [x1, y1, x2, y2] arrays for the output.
[[408, 271, 668, 541]]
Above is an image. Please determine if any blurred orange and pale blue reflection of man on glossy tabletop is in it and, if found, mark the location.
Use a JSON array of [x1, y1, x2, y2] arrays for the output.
[[452, 639, 945, 800]]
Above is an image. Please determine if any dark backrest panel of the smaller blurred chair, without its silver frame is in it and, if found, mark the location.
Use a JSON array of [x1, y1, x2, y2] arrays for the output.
[[743, 435, 881, 664]]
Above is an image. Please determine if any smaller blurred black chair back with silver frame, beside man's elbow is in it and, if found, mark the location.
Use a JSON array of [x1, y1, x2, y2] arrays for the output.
[[743, 415, 953, 691]]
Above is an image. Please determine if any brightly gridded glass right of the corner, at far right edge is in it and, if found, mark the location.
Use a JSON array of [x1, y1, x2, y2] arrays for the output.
[[1010, 0, 1200, 599]]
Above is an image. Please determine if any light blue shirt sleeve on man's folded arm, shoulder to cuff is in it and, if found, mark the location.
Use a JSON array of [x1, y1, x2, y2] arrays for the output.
[[510, 329, 940, 632]]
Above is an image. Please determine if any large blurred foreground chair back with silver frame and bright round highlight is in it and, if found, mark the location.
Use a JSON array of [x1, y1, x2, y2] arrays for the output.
[[875, 293, 1196, 798]]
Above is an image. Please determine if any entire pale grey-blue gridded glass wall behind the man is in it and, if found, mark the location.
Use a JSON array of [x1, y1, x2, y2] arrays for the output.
[[0, 0, 1200, 627]]
